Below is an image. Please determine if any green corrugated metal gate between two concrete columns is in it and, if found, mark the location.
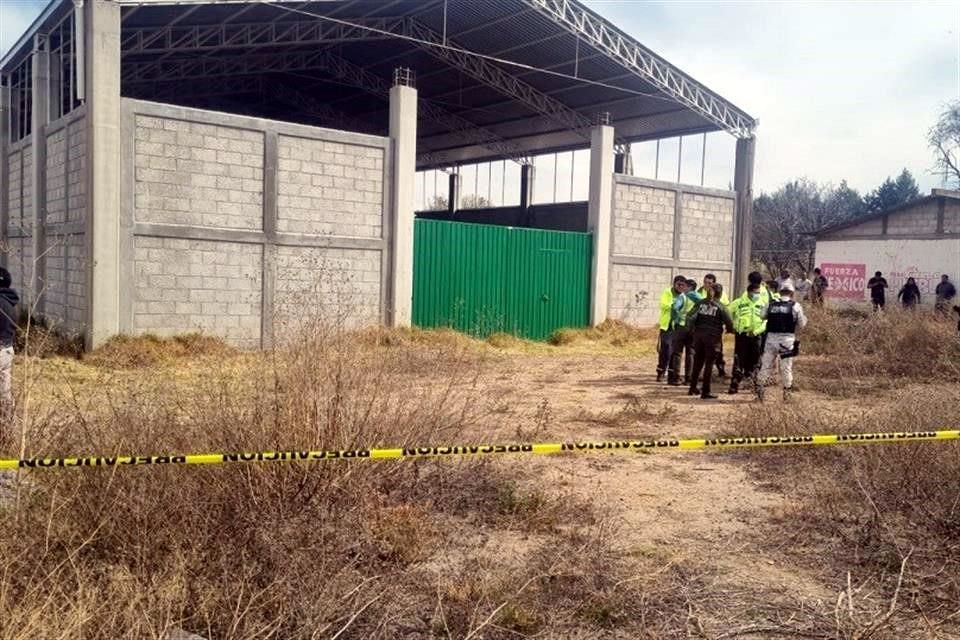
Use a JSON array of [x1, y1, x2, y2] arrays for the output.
[[413, 219, 593, 340]]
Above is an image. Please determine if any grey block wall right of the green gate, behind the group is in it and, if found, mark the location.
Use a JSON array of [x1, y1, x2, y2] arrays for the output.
[[608, 175, 736, 325]]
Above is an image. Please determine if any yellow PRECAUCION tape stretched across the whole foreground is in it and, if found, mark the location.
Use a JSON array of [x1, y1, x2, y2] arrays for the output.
[[0, 429, 960, 470]]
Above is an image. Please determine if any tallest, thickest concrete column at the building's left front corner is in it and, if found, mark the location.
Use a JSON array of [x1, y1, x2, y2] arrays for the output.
[[83, 0, 121, 349]]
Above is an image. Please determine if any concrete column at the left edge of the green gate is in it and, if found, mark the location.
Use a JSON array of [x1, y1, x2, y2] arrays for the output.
[[390, 76, 417, 327]]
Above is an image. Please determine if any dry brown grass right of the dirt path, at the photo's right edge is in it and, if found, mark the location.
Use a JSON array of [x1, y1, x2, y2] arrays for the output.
[[731, 340, 960, 639]]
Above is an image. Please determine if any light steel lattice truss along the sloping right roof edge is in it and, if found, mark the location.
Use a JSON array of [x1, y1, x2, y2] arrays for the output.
[[521, 0, 757, 138]]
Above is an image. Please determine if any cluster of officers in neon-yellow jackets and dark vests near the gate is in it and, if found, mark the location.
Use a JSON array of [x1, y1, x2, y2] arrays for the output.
[[657, 271, 808, 400]]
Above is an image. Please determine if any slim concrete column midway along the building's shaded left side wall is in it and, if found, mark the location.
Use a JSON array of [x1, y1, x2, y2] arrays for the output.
[[25, 34, 50, 314]]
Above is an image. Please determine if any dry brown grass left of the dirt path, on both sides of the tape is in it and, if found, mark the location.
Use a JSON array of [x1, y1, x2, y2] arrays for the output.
[[0, 329, 704, 640]]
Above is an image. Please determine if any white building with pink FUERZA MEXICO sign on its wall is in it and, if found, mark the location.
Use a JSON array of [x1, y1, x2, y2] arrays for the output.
[[817, 189, 960, 304]]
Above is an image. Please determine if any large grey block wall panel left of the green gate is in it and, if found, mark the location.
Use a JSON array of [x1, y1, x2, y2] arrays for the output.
[[119, 99, 391, 347]]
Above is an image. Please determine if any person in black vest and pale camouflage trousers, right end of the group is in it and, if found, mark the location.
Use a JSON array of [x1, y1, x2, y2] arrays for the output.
[[757, 282, 807, 401]]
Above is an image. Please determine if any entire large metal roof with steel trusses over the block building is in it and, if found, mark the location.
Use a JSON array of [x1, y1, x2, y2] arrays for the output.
[[0, 0, 756, 168]]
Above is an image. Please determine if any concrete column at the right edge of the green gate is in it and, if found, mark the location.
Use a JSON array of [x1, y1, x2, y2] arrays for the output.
[[587, 125, 614, 325]]
